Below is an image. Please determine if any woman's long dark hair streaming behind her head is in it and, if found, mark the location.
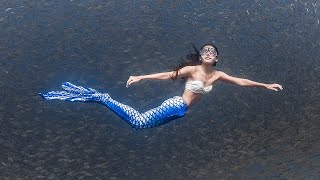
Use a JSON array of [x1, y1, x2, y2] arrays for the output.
[[172, 43, 219, 80]]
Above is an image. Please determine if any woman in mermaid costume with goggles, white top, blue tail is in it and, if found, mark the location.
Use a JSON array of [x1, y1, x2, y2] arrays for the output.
[[40, 44, 282, 129]]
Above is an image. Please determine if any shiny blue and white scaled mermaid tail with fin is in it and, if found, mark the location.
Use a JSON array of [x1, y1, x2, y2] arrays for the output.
[[39, 82, 187, 129]]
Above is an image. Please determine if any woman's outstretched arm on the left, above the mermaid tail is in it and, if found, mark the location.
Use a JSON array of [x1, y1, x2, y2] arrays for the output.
[[127, 66, 194, 87]]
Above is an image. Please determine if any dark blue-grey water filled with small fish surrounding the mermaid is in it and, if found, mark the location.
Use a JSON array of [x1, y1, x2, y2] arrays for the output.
[[0, 0, 320, 179]]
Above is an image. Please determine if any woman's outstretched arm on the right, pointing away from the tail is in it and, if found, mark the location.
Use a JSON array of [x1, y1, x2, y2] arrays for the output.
[[219, 71, 283, 91]]
